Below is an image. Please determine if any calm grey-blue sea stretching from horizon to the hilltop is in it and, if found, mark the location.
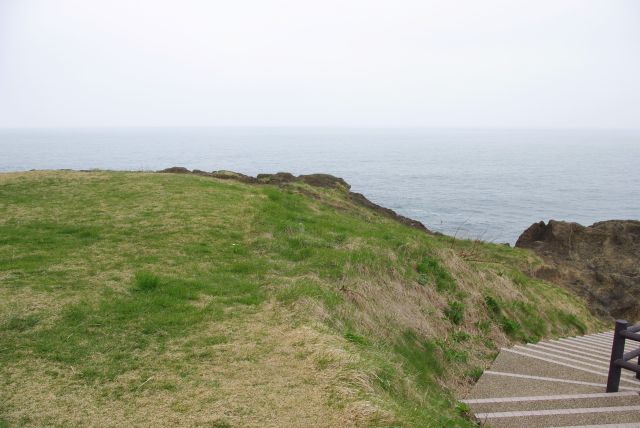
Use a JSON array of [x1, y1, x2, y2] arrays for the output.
[[0, 128, 640, 243]]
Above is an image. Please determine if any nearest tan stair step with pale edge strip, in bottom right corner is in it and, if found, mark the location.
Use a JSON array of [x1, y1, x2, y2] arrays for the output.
[[476, 406, 640, 428]]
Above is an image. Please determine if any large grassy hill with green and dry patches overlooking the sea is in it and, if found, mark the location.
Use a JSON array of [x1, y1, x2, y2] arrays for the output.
[[0, 171, 601, 427]]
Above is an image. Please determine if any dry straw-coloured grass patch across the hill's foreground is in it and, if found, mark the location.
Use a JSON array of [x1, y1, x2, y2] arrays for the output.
[[0, 304, 391, 427]]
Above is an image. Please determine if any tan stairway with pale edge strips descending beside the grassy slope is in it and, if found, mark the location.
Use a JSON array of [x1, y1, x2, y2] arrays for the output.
[[462, 332, 640, 428]]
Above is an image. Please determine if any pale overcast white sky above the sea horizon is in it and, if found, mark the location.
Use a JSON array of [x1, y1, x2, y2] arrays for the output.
[[0, 0, 640, 128]]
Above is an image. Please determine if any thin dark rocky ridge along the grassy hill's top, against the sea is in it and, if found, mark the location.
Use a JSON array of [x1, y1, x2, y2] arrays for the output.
[[158, 166, 432, 233]]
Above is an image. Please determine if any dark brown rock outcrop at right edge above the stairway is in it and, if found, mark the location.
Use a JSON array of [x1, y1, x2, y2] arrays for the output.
[[516, 220, 640, 322]]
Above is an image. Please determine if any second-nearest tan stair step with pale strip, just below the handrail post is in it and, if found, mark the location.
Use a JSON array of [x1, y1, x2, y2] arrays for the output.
[[463, 391, 640, 413]]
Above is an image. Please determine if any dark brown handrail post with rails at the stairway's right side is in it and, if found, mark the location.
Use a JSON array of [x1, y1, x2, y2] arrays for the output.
[[607, 320, 640, 392]]
